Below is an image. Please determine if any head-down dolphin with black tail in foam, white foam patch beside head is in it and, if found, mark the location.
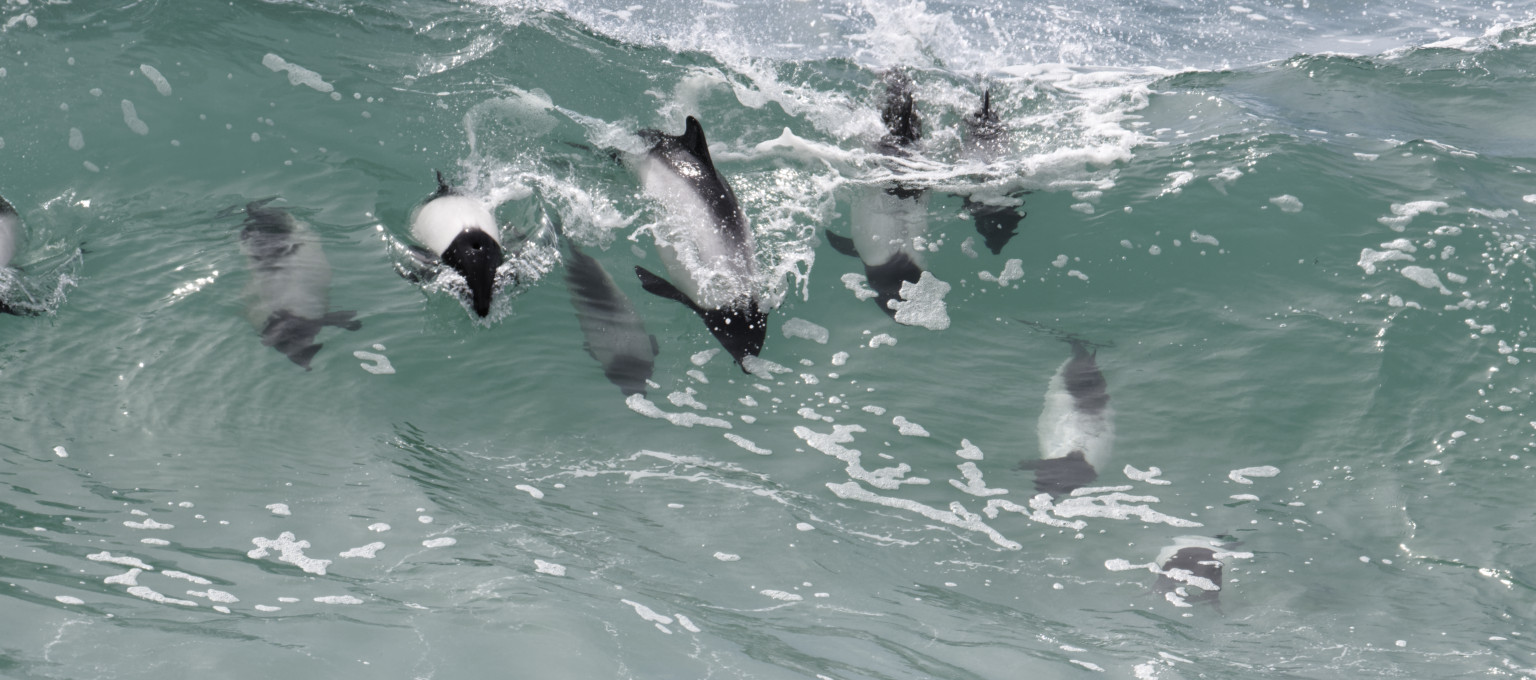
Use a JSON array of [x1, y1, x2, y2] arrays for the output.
[[826, 71, 928, 318]]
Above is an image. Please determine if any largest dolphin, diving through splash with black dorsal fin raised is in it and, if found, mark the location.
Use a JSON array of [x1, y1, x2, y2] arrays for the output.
[[634, 115, 768, 370]]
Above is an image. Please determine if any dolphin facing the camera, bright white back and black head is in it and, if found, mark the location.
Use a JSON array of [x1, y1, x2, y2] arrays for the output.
[[410, 172, 507, 318]]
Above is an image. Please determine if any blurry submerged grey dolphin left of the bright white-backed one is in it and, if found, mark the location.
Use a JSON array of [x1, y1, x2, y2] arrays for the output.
[[240, 198, 362, 370]]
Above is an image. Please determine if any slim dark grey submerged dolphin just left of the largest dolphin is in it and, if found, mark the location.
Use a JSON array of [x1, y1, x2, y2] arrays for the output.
[[565, 241, 660, 396]]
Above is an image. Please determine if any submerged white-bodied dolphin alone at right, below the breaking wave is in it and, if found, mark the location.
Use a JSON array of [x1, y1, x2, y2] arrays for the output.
[[1018, 338, 1115, 496]]
